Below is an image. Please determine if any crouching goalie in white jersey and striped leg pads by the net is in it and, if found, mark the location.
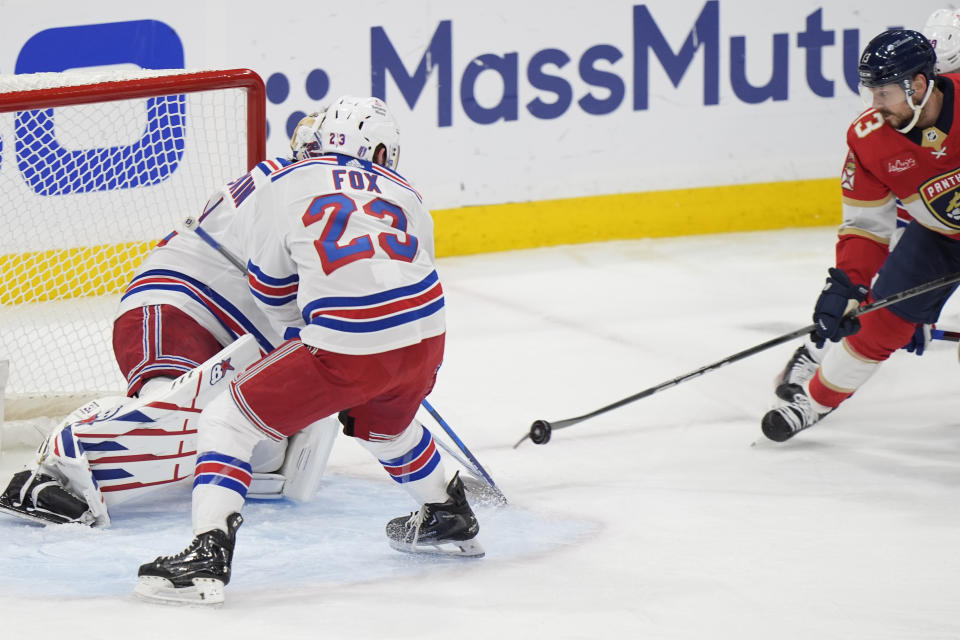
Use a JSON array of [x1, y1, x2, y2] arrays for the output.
[[0, 114, 337, 525]]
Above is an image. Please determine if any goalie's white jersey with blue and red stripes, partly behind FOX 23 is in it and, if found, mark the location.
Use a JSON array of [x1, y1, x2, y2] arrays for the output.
[[116, 158, 294, 353]]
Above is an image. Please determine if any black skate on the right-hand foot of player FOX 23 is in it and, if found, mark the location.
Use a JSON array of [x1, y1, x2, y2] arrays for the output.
[[387, 472, 484, 558]]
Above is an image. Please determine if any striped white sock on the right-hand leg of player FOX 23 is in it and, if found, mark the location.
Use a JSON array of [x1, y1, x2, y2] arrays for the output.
[[360, 421, 447, 504]]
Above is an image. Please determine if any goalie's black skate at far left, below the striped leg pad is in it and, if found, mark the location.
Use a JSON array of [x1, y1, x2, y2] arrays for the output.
[[0, 470, 94, 525]]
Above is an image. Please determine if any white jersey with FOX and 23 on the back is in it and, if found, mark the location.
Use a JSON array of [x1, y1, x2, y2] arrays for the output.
[[240, 154, 445, 355]]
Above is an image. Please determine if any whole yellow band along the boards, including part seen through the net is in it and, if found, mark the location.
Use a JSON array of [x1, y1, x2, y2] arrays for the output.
[[0, 178, 840, 305]]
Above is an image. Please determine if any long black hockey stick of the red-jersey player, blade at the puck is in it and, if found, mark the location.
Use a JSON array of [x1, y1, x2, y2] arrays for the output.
[[513, 273, 960, 449]]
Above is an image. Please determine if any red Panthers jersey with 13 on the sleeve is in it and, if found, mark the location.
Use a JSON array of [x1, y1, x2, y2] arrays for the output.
[[837, 74, 960, 284]]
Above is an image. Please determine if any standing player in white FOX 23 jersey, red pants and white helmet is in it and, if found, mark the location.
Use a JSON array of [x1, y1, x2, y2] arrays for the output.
[[135, 97, 483, 604]]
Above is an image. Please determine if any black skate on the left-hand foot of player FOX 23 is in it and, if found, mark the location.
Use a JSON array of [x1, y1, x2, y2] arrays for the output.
[[133, 513, 243, 605]]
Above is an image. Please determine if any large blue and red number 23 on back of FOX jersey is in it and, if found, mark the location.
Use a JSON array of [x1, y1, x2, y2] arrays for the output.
[[303, 193, 419, 275]]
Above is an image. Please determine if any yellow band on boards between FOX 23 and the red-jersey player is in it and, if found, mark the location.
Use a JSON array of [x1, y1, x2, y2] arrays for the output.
[[433, 178, 840, 256]]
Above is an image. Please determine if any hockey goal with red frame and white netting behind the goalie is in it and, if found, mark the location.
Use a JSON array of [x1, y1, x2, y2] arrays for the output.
[[0, 69, 266, 420]]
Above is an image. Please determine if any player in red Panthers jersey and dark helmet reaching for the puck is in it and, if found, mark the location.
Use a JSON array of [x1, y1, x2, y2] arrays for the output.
[[762, 30, 960, 442]]
